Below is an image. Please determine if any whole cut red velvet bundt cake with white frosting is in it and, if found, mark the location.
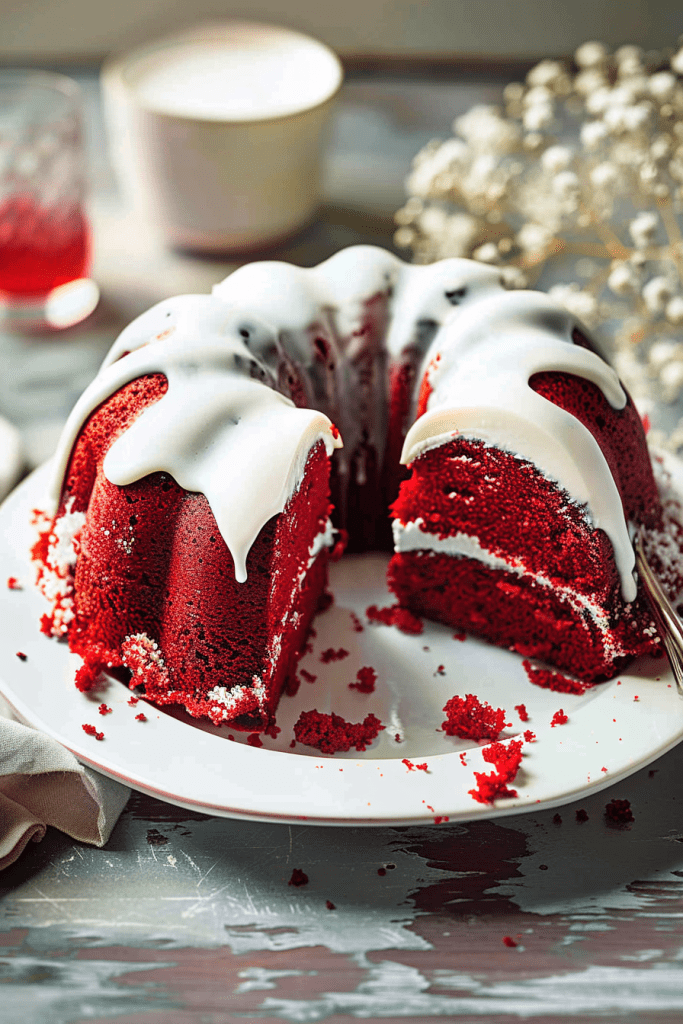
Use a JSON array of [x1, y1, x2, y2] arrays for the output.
[[34, 247, 681, 730]]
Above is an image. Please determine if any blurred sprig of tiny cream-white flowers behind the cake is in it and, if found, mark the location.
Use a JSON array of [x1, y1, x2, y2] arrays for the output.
[[395, 37, 683, 447]]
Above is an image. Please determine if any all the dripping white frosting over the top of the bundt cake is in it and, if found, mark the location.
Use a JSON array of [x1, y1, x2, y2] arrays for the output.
[[52, 246, 636, 601]]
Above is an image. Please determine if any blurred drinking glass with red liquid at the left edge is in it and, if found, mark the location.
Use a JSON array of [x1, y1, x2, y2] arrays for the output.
[[0, 71, 99, 330]]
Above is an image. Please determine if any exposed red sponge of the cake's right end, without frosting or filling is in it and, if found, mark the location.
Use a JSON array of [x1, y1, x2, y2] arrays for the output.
[[389, 373, 661, 680]]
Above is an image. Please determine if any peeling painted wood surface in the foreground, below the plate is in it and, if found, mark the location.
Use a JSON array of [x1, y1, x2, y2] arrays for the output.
[[0, 749, 683, 1024]]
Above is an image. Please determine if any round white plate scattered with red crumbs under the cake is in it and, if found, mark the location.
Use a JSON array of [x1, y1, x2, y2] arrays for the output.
[[0, 463, 683, 824]]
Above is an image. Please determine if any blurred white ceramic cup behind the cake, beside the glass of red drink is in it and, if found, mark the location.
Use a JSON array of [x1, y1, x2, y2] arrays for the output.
[[102, 22, 343, 253]]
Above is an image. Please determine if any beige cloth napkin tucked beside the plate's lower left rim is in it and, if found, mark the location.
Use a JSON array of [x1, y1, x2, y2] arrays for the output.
[[0, 696, 130, 870]]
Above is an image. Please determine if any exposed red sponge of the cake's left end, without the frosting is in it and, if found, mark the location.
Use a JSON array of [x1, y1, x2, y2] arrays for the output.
[[38, 375, 330, 730]]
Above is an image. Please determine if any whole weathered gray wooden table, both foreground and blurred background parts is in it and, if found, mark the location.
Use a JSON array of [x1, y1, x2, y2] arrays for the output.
[[0, 70, 683, 1024]]
